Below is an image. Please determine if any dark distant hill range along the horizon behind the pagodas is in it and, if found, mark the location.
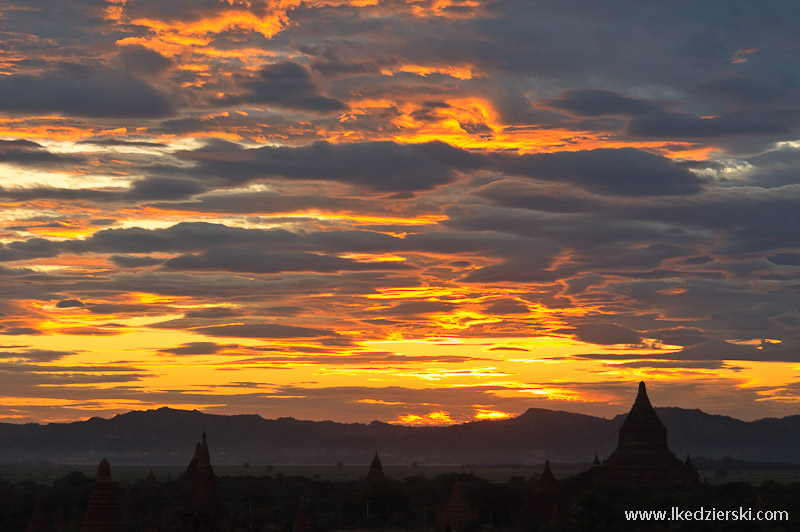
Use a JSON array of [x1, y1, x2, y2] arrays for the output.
[[0, 408, 800, 464]]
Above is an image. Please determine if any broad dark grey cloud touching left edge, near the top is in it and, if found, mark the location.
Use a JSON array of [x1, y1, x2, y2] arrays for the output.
[[0, 64, 174, 118]]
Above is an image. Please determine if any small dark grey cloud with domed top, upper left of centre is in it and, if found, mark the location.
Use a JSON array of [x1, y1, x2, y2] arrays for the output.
[[220, 61, 347, 113]]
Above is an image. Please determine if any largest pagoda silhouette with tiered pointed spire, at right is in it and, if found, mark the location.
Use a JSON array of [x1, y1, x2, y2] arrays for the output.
[[592, 381, 699, 484]]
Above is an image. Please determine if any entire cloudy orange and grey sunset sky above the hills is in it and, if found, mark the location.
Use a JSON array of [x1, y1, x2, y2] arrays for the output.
[[0, 0, 800, 424]]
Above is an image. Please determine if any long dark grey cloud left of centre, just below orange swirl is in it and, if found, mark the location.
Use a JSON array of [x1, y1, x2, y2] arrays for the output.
[[181, 141, 483, 192]]
